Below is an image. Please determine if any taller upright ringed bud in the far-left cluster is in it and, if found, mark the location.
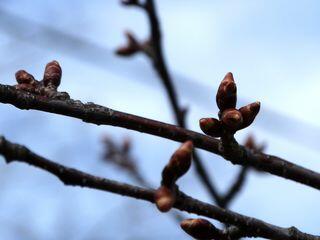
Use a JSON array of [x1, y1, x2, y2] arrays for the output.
[[43, 61, 62, 87]]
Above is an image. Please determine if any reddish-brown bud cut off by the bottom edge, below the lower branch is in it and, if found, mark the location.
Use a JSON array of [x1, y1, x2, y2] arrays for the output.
[[180, 218, 224, 240]]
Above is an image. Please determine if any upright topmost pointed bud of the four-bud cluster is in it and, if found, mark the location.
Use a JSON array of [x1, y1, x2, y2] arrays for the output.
[[216, 72, 237, 111]]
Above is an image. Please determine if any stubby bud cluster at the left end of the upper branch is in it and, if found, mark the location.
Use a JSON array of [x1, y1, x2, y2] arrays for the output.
[[15, 61, 68, 97]]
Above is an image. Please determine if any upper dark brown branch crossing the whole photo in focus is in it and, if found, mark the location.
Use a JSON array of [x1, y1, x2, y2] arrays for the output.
[[0, 84, 320, 189]]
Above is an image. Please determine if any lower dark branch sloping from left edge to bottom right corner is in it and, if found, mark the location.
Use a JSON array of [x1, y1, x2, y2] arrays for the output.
[[0, 137, 320, 240]]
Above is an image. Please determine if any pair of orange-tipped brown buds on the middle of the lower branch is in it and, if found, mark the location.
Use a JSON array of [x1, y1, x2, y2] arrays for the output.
[[154, 141, 193, 212]]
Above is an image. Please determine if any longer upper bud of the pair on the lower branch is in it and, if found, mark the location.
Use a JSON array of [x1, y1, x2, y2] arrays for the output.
[[162, 141, 193, 187]]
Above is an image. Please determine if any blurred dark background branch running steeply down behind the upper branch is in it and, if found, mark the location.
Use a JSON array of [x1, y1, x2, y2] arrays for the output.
[[117, 0, 221, 203]]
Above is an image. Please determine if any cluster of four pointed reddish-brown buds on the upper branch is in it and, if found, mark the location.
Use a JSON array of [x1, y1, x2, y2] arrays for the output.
[[200, 73, 260, 137]]
